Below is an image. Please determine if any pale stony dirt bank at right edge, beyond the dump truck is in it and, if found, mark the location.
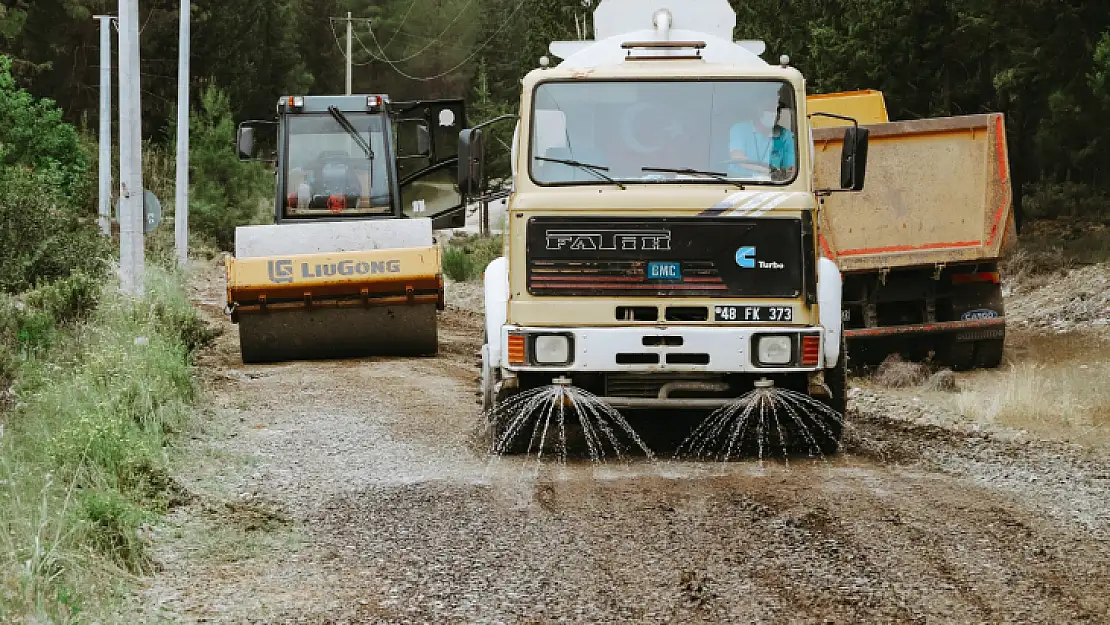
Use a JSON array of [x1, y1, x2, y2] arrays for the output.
[[1006, 263, 1110, 332]]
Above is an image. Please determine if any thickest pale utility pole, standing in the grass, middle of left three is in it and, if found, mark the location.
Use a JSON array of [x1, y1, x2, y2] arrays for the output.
[[120, 0, 145, 298]]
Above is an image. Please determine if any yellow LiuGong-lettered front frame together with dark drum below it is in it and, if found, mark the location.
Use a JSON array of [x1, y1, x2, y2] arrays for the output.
[[226, 246, 444, 363]]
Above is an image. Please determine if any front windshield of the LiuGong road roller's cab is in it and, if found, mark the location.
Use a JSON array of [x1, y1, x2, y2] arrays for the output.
[[285, 112, 392, 216]]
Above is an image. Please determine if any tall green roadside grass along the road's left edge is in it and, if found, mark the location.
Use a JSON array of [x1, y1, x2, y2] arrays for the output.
[[0, 268, 211, 623]]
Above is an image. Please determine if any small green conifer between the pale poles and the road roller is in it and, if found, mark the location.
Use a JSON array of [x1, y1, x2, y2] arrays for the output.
[[189, 87, 273, 250]]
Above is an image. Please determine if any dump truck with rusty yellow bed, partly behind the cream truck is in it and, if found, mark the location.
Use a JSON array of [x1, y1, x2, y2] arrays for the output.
[[808, 91, 1016, 370]]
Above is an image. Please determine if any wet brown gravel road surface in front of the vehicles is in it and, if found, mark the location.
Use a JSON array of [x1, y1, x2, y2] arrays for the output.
[[136, 261, 1110, 623]]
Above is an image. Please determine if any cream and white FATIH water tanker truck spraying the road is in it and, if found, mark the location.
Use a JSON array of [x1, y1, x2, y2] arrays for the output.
[[458, 0, 868, 453]]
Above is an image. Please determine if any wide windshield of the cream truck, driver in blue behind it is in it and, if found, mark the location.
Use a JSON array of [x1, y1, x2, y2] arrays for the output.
[[529, 80, 798, 184]]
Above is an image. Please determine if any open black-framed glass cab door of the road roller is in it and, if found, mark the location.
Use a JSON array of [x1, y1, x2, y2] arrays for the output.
[[391, 100, 466, 229]]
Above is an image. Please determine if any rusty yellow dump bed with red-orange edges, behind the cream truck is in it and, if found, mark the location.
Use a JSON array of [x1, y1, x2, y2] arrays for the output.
[[810, 113, 1013, 273]]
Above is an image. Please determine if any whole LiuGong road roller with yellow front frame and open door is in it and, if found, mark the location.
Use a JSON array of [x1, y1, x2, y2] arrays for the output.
[[226, 94, 465, 363]]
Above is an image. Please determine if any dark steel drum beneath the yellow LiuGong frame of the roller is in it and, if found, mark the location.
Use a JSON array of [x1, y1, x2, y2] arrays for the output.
[[239, 304, 438, 364]]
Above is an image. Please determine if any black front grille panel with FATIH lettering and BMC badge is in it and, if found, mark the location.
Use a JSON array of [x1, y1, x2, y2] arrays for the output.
[[526, 215, 814, 298]]
